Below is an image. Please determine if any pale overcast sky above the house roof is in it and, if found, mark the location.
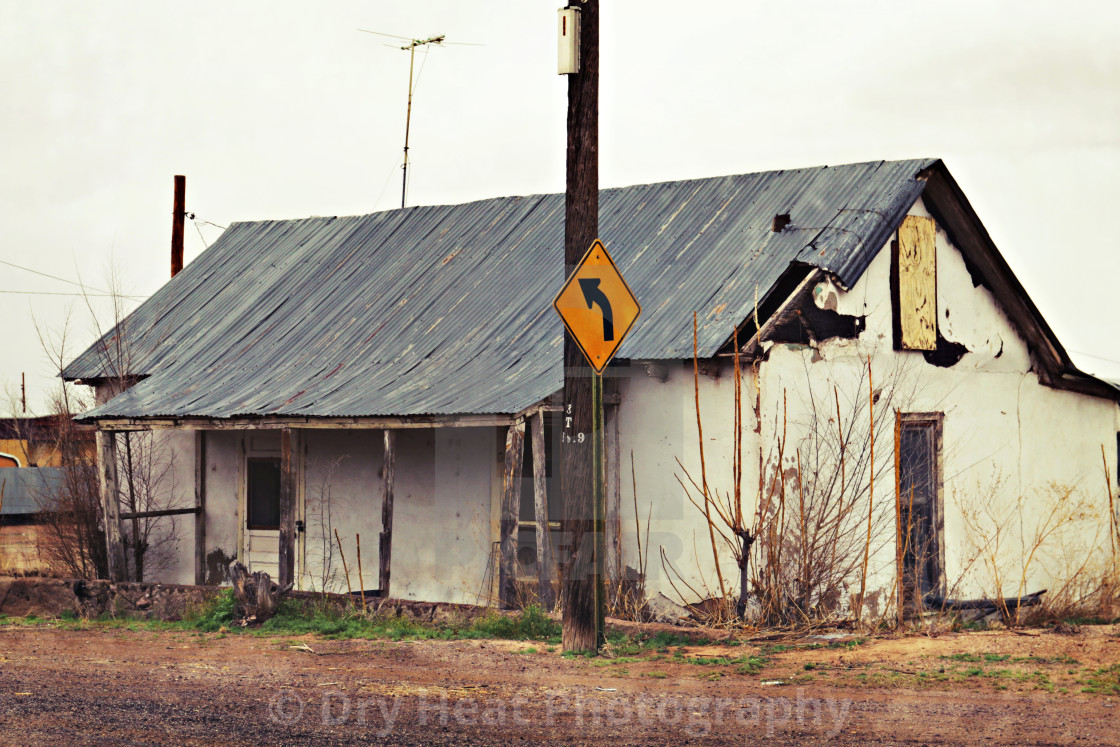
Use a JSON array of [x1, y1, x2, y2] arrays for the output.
[[0, 0, 1120, 410]]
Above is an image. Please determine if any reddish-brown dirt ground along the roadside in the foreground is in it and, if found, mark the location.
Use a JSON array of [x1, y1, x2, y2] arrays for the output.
[[0, 623, 1120, 745]]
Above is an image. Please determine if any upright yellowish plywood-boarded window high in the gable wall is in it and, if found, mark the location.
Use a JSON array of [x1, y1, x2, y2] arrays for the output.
[[890, 215, 937, 351]]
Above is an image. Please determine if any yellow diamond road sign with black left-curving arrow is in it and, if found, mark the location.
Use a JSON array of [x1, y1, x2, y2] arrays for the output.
[[552, 239, 642, 374]]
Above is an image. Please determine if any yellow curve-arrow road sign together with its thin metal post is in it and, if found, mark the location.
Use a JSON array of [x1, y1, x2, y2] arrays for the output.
[[552, 239, 642, 651]]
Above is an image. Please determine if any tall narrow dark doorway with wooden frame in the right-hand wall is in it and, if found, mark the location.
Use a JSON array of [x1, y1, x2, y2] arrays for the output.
[[896, 413, 942, 609]]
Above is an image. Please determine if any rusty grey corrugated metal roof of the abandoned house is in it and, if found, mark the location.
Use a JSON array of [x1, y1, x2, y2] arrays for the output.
[[65, 160, 936, 419]]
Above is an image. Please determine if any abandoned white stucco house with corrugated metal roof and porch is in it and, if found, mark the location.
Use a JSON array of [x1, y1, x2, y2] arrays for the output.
[[64, 160, 1120, 613]]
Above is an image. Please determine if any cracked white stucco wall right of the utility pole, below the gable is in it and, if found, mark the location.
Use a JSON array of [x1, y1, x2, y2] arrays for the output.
[[619, 195, 1120, 615]]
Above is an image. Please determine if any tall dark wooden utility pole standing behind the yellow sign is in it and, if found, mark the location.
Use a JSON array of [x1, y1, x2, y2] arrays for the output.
[[561, 0, 603, 651]]
